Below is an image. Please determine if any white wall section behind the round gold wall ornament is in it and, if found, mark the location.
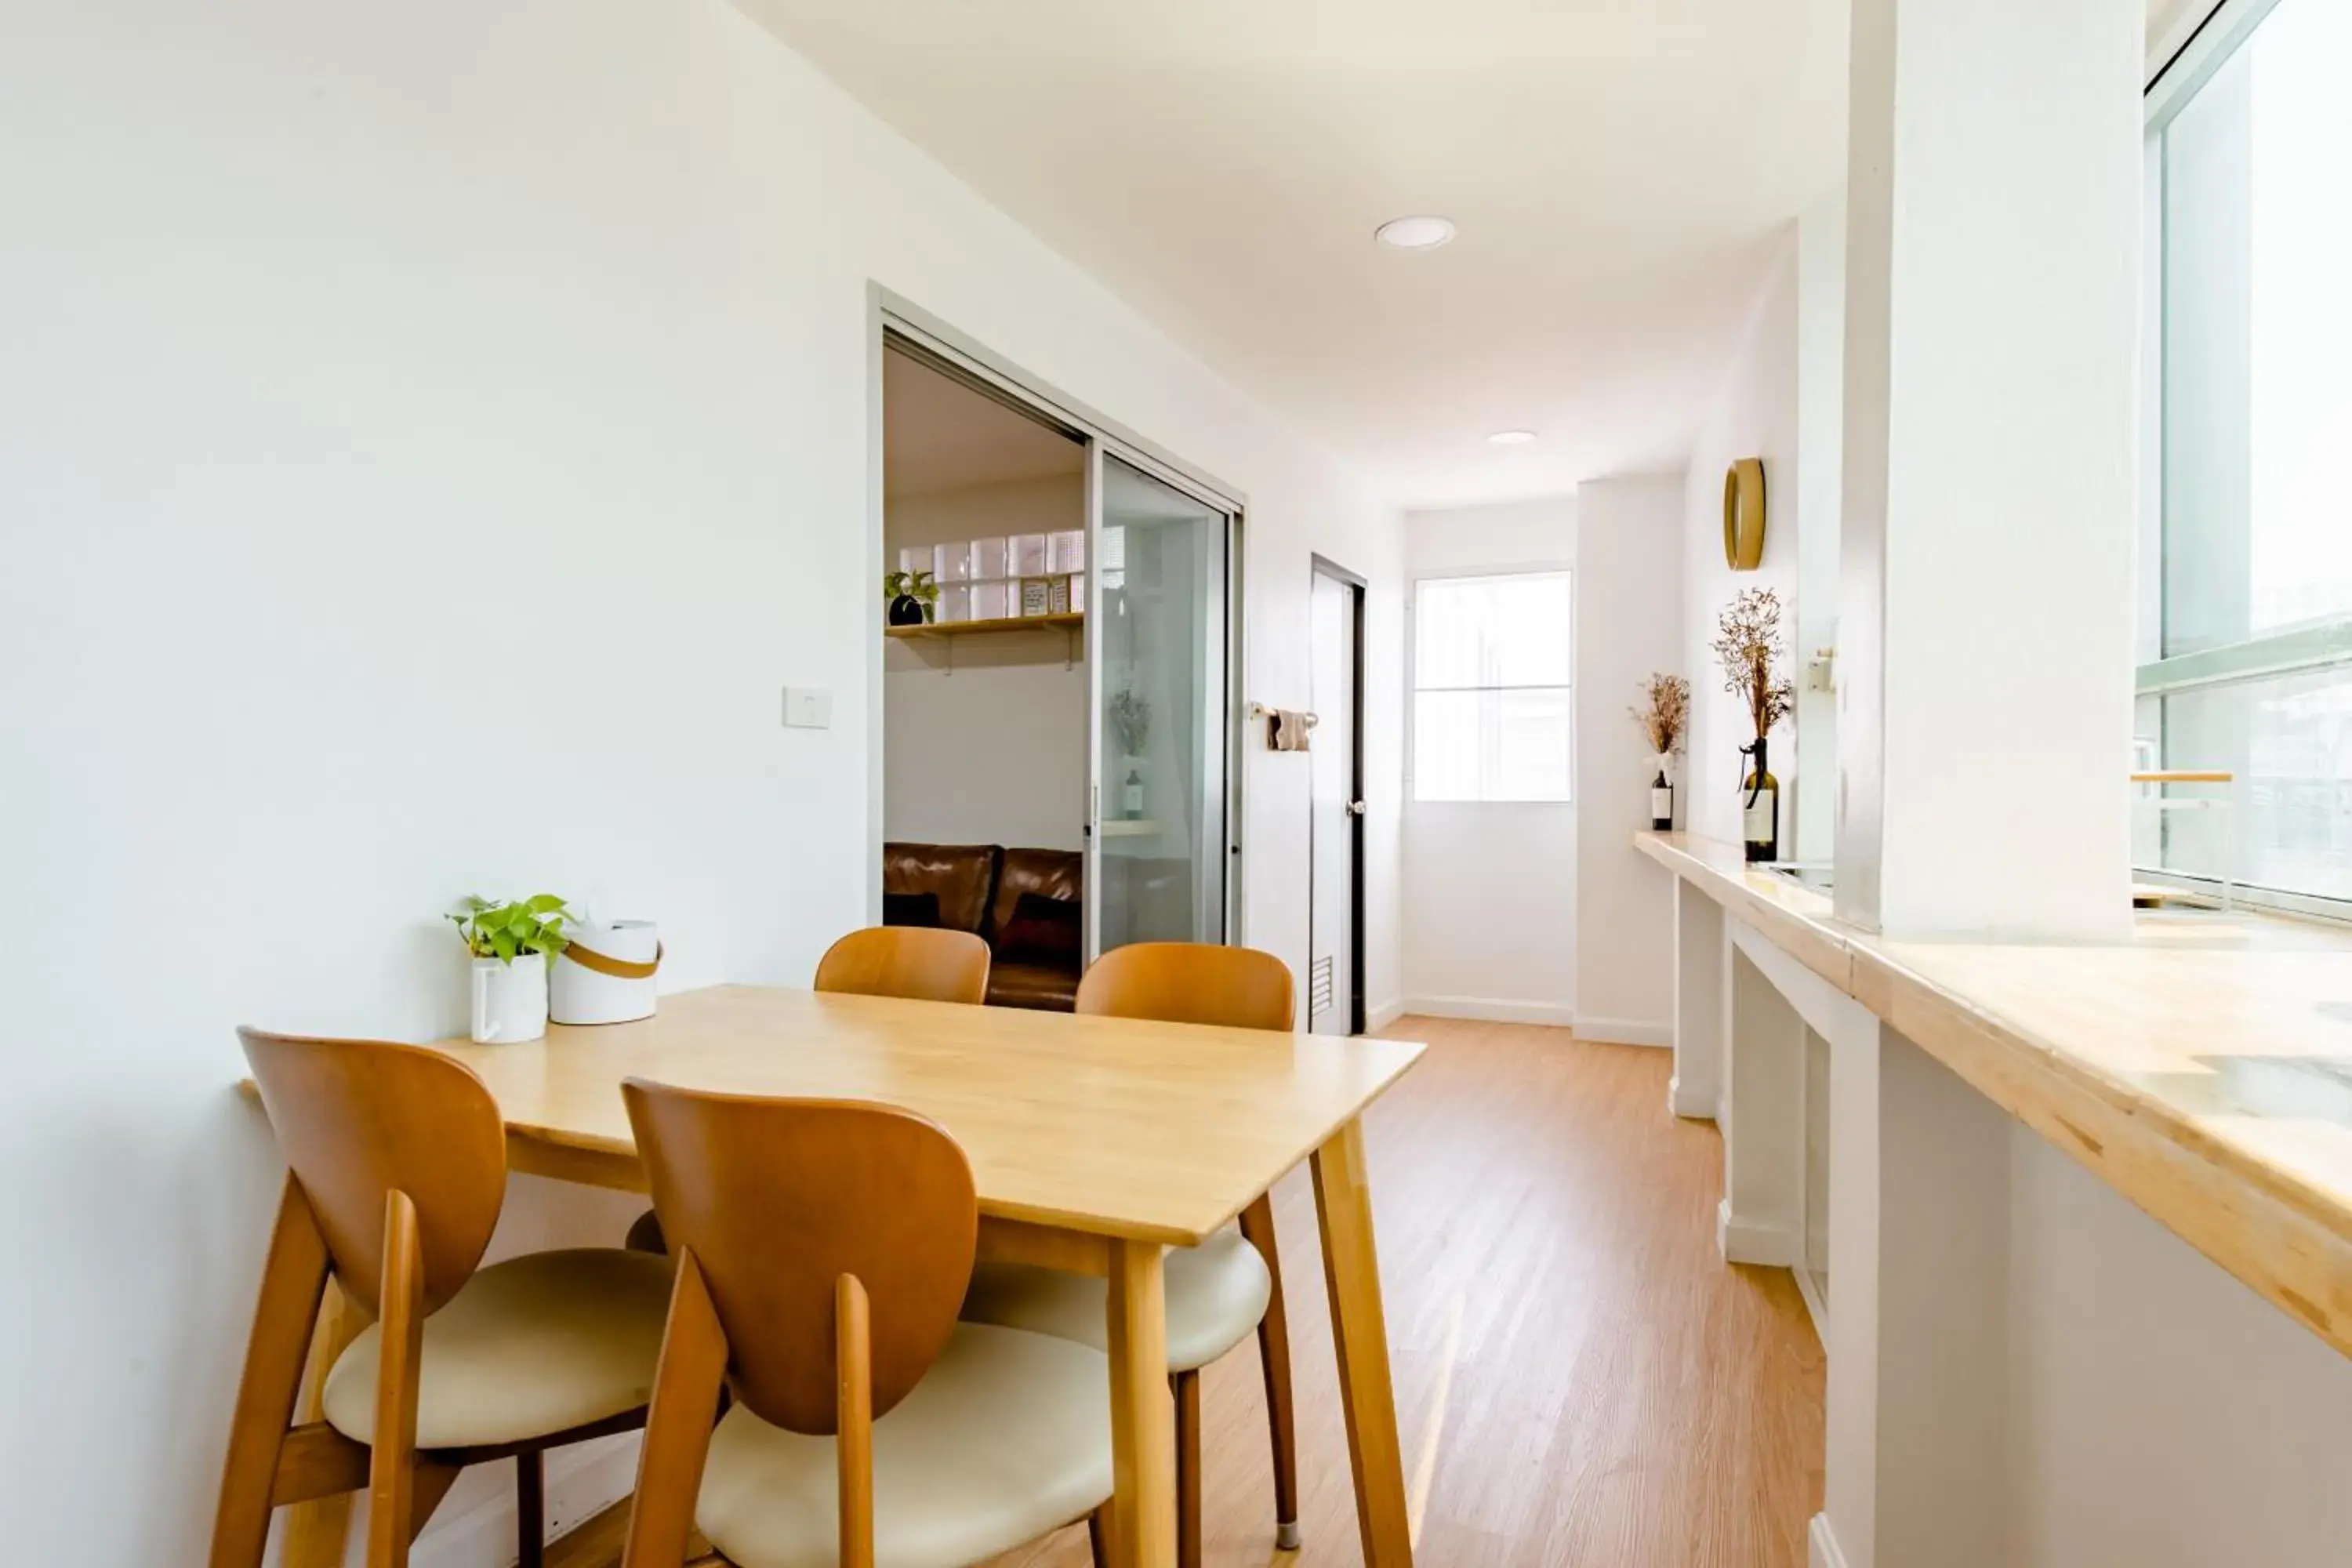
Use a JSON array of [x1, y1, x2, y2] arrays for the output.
[[1682, 228, 1799, 844]]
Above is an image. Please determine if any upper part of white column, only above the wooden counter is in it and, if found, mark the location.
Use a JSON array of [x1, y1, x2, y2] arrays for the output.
[[1837, 0, 2145, 938]]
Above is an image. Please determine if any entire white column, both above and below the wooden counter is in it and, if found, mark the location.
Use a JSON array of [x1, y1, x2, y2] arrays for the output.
[[1813, 0, 2145, 1568]]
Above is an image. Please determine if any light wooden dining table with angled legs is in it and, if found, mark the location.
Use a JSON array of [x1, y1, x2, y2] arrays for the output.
[[267, 985, 1423, 1568]]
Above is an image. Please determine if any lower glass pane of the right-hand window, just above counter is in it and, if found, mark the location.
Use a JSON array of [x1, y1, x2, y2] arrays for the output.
[[2161, 670, 2352, 898]]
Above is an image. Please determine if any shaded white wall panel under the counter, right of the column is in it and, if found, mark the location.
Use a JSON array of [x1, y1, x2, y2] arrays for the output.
[[2002, 1126, 2352, 1568]]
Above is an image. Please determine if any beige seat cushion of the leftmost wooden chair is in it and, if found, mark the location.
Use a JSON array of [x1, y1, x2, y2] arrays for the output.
[[320, 1248, 670, 1448]]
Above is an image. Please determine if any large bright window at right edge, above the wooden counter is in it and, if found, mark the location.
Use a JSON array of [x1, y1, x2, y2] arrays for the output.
[[2133, 0, 2352, 900]]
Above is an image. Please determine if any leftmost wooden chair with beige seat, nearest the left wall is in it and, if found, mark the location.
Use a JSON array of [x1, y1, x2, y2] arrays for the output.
[[209, 1029, 670, 1568]]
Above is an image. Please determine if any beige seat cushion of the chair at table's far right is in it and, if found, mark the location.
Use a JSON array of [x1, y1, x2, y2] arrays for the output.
[[964, 1225, 1275, 1373]]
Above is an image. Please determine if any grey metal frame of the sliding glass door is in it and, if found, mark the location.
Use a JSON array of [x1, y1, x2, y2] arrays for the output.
[[866, 280, 1249, 959]]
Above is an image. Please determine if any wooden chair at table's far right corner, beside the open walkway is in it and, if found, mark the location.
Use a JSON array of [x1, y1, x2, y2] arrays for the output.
[[964, 942, 1298, 1568]]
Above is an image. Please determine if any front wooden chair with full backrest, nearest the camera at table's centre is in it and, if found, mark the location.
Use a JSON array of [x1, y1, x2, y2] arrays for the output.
[[621, 1079, 1112, 1568]]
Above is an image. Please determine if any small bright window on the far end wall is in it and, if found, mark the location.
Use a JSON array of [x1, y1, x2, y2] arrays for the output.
[[1414, 572, 1573, 801]]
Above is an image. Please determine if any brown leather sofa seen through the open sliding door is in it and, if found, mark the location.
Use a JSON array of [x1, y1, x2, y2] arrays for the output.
[[882, 844, 1084, 1013]]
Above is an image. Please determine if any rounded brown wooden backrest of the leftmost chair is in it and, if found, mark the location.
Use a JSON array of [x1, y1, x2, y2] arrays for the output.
[[238, 1029, 506, 1316]]
